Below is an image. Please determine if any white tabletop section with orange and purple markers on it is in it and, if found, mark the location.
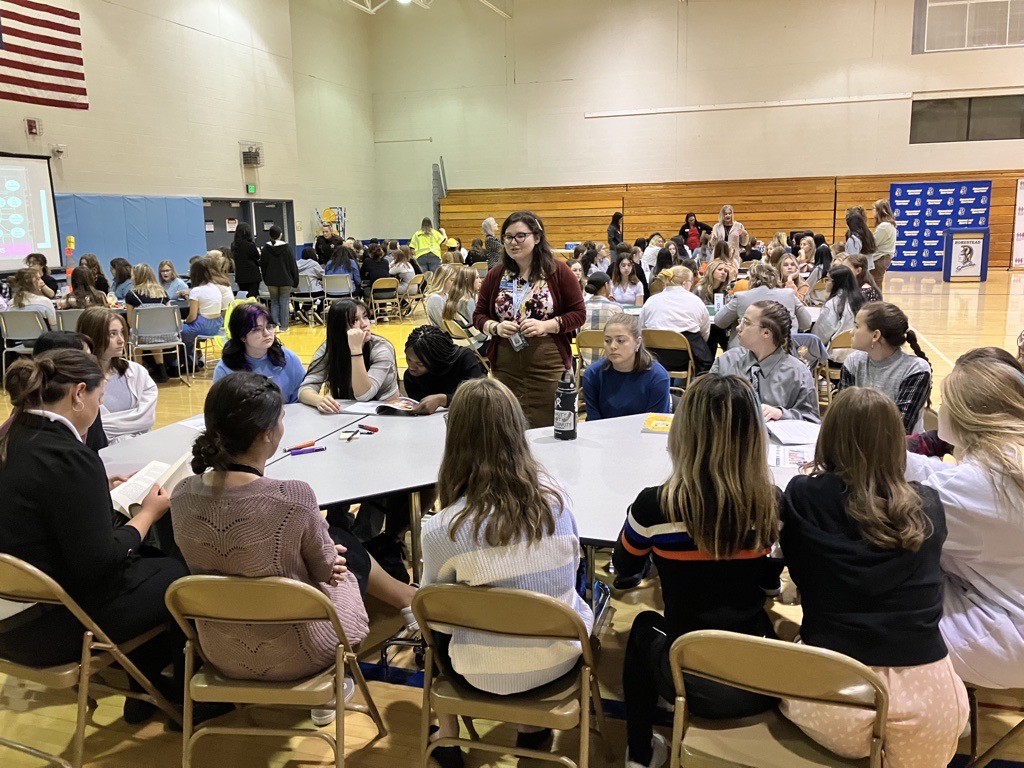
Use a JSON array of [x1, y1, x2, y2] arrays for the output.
[[266, 409, 445, 505]]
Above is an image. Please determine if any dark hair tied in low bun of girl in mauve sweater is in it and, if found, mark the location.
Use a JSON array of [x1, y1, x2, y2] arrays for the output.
[[191, 371, 285, 474]]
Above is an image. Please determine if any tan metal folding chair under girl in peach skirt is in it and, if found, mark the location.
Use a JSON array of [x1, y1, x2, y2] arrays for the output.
[[667, 625, 889, 768]]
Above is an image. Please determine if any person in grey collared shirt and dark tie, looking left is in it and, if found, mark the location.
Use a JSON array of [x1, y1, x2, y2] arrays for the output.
[[711, 301, 821, 424]]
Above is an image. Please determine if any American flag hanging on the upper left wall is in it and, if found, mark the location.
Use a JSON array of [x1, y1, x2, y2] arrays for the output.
[[0, 0, 89, 110]]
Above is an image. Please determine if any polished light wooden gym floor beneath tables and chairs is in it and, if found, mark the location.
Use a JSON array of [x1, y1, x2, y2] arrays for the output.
[[0, 271, 1024, 768]]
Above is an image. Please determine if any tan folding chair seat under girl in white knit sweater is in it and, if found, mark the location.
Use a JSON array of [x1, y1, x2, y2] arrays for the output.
[[430, 669, 580, 730]]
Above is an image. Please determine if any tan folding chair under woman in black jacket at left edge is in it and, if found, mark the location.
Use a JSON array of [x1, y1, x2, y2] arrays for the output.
[[0, 554, 181, 768]]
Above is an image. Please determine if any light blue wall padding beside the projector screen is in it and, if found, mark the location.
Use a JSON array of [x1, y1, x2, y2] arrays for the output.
[[56, 195, 206, 274]]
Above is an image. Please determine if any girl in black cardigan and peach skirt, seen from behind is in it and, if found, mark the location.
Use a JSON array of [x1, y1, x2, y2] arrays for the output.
[[781, 387, 968, 768]]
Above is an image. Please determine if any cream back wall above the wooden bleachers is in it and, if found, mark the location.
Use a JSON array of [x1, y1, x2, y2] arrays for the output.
[[372, 0, 1024, 237]]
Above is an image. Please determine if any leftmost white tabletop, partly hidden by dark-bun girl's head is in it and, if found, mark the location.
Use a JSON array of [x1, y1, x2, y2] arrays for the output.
[[99, 402, 360, 474]]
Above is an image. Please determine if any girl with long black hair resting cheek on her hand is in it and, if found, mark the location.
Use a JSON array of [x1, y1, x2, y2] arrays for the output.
[[299, 299, 398, 414]]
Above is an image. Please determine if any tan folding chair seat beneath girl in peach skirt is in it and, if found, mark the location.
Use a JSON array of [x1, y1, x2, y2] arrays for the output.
[[683, 710, 870, 768]]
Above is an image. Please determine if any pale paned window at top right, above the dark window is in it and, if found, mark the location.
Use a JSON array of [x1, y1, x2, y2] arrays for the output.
[[913, 0, 1024, 53]]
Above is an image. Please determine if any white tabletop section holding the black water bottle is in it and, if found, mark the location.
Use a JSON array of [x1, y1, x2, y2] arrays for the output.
[[526, 414, 797, 546]]
